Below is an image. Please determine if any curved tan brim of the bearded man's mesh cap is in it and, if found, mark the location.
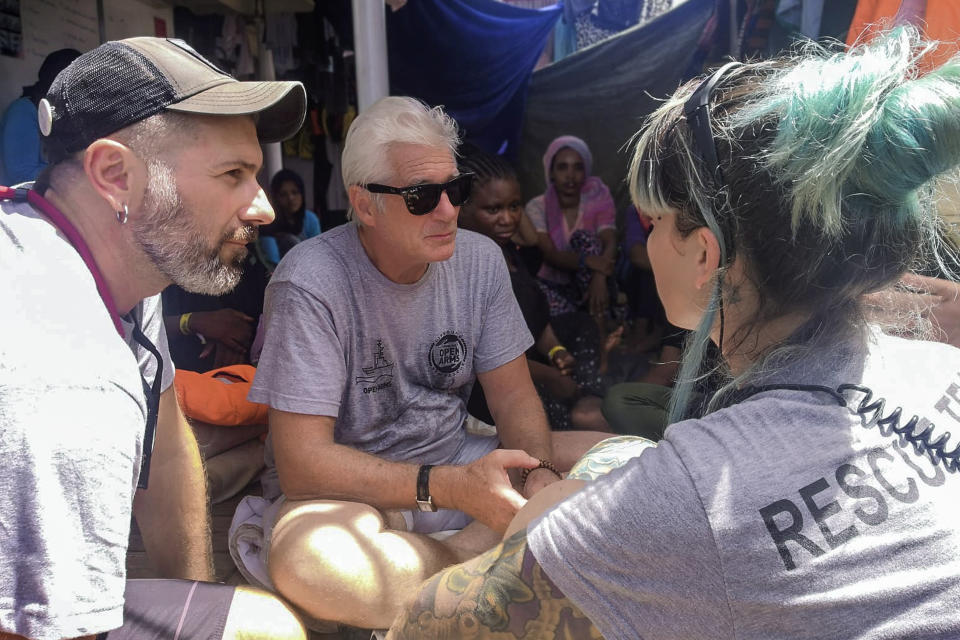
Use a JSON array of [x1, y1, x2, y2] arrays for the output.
[[167, 80, 307, 142]]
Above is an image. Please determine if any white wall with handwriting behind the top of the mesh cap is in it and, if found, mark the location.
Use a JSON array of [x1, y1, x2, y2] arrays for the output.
[[0, 0, 173, 113]]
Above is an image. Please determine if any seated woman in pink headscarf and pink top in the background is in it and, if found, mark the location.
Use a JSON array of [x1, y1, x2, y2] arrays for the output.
[[526, 136, 617, 318]]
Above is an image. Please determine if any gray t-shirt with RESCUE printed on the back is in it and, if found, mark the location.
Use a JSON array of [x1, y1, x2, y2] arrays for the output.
[[528, 335, 960, 640]]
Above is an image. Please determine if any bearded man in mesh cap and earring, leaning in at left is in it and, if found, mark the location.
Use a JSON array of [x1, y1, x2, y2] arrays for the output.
[[0, 38, 306, 640]]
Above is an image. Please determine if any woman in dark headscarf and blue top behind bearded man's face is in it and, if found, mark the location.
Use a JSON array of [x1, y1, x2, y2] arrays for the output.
[[258, 169, 320, 272]]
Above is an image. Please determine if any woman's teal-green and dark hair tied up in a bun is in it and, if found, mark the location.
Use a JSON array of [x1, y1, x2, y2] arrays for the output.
[[628, 27, 960, 420]]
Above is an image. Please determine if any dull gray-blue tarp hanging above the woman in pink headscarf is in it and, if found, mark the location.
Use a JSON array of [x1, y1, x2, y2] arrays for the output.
[[518, 0, 714, 209]]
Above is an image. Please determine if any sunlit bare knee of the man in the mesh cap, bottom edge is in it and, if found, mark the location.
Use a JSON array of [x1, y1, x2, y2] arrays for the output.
[[223, 587, 307, 640]]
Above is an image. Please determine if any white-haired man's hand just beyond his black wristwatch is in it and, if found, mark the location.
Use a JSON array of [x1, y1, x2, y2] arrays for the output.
[[440, 449, 540, 534]]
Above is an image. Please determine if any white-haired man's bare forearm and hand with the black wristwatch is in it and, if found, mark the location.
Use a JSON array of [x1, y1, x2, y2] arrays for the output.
[[270, 408, 537, 532]]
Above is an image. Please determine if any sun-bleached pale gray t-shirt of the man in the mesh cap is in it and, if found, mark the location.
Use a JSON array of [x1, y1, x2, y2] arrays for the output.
[[0, 202, 173, 640]]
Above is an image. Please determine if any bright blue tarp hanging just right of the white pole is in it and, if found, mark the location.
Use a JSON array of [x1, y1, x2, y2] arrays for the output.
[[387, 0, 562, 157]]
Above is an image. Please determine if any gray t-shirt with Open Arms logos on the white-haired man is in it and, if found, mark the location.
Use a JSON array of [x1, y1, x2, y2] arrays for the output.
[[250, 223, 533, 488]]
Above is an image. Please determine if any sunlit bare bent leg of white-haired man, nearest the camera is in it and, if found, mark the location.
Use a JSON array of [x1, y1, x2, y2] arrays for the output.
[[269, 500, 499, 629]]
